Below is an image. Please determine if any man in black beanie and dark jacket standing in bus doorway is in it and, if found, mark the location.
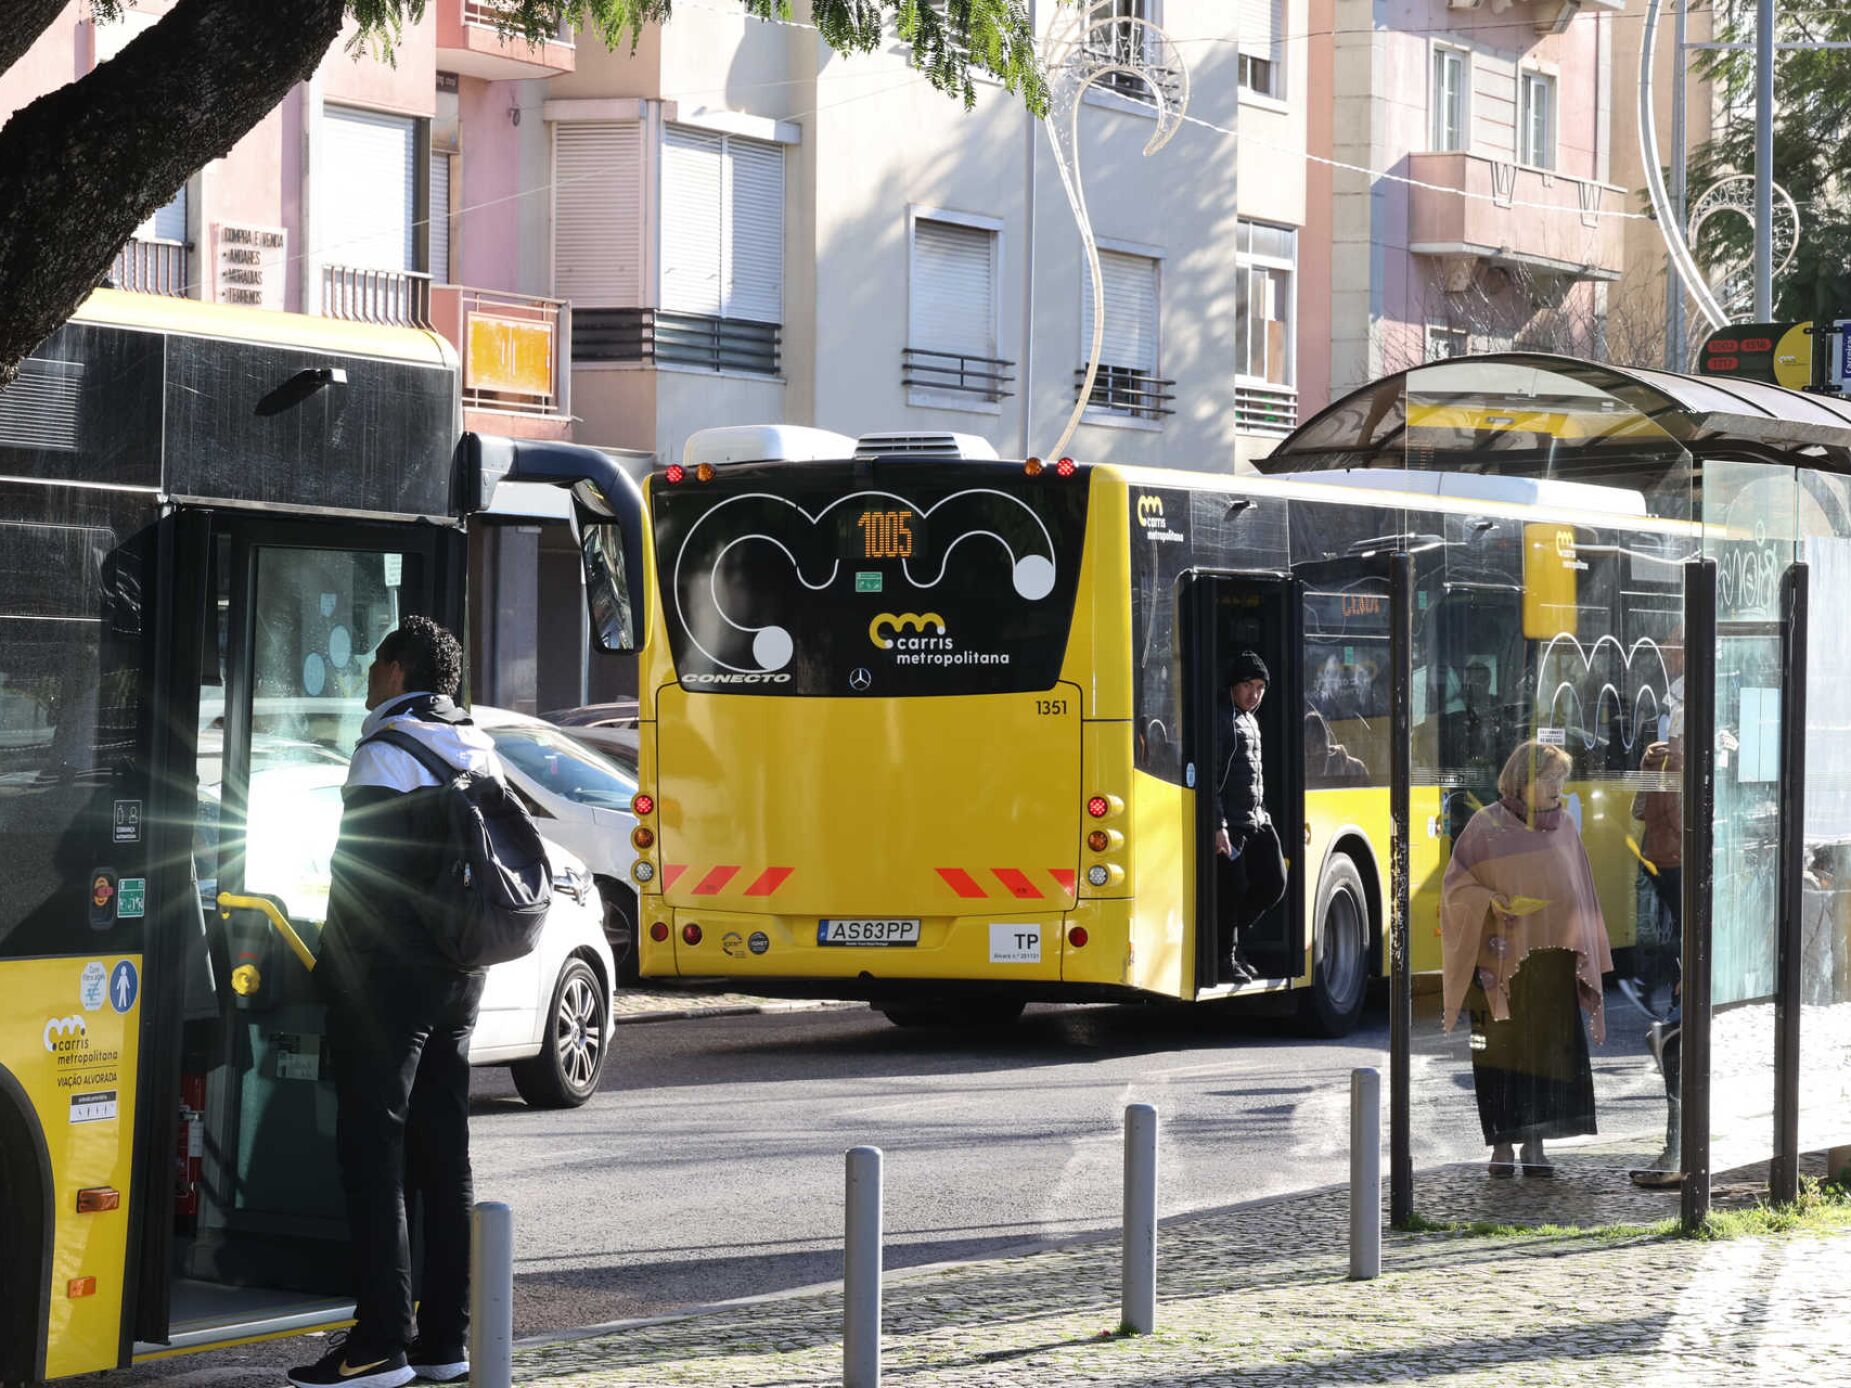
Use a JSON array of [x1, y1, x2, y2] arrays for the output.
[[1214, 651, 1285, 983]]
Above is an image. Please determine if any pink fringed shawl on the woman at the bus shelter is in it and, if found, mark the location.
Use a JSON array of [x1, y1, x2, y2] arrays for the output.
[[1440, 799, 1614, 1042]]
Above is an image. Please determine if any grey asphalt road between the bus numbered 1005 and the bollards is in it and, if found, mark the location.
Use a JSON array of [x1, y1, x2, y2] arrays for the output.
[[93, 994, 1664, 1384]]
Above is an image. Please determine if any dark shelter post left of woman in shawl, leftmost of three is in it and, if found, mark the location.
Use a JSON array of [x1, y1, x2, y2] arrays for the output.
[[1388, 550, 1414, 1229]]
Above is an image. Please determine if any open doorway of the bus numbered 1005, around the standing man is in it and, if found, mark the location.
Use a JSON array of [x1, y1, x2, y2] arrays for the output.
[[1181, 570, 1305, 998]]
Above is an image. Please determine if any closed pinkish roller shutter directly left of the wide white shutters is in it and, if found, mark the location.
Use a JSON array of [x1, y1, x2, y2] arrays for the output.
[[553, 120, 642, 309]]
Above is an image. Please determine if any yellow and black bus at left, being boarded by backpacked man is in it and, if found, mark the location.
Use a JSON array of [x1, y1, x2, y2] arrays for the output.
[[0, 291, 611, 1384]]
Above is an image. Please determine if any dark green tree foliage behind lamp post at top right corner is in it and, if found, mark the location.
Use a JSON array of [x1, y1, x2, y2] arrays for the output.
[[1690, 0, 1851, 322]]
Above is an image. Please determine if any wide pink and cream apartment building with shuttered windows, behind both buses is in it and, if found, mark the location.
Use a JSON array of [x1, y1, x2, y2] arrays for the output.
[[0, 0, 1307, 709]]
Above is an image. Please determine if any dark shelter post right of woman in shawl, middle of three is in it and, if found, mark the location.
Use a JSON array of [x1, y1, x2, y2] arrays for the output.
[[1679, 559, 1716, 1231]]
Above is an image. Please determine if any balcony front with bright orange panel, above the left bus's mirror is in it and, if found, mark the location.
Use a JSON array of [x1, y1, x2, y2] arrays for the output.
[[431, 285, 572, 418]]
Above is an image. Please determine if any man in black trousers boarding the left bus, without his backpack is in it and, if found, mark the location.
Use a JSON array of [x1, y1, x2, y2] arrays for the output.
[[289, 616, 500, 1388]]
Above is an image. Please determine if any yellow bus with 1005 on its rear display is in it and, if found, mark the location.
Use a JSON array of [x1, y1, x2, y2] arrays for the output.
[[536, 386, 1694, 1035]]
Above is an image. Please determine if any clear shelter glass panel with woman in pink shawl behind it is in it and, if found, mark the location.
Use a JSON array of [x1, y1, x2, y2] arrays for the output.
[[1372, 357, 1701, 1223]]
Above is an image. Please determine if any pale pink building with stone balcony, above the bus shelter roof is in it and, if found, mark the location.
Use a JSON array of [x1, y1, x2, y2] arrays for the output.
[[1301, 0, 1636, 409]]
